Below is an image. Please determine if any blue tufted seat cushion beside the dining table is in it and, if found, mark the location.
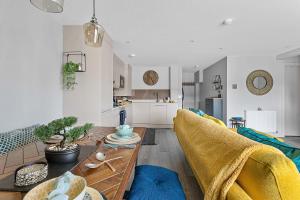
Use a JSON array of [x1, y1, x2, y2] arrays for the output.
[[128, 165, 185, 200]]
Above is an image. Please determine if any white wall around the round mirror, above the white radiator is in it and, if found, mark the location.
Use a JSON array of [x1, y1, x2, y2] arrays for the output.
[[226, 56, 284, 136]]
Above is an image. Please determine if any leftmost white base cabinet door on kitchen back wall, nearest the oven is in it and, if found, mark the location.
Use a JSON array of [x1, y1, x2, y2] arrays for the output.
[[132, 102, 150, 124]]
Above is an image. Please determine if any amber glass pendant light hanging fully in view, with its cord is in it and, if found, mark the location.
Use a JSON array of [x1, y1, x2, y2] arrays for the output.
[[83, 0, 105, 47]]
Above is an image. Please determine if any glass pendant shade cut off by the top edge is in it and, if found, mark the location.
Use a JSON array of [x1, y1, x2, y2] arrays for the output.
[[30, 0, 64, 13]]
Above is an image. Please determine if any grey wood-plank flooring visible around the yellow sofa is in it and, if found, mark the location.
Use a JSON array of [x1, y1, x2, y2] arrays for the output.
[[138, 129, 300, 200]]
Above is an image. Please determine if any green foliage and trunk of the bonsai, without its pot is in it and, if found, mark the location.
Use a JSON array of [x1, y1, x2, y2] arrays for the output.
[[34, 117, 93, 147]]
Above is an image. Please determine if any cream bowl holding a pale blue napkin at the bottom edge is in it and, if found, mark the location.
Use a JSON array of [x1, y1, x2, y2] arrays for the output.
[[23, 176, 87, 200]]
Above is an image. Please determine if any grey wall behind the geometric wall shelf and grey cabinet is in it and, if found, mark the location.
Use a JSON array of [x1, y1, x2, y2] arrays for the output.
[[200, 57, 228, 122]]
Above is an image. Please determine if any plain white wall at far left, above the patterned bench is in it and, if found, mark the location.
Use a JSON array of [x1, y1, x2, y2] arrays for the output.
[[0, 0, 62, 131]]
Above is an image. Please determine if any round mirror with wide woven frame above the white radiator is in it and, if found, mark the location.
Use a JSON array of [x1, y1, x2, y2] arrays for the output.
[[246, 70, 273, 95]]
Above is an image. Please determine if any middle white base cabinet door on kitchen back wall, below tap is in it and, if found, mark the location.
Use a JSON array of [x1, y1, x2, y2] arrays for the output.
[[150, 103, 168, 124]]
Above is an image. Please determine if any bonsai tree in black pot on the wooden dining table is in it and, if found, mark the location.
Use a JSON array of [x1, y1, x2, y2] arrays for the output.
[[34, 117, 93, 163]]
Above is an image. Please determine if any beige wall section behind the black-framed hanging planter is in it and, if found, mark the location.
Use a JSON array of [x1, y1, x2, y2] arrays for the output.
[[63, 25, 113, 125]]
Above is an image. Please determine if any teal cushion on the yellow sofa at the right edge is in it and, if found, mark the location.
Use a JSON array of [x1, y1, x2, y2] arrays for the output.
[[237, 127, 300, 171]]
